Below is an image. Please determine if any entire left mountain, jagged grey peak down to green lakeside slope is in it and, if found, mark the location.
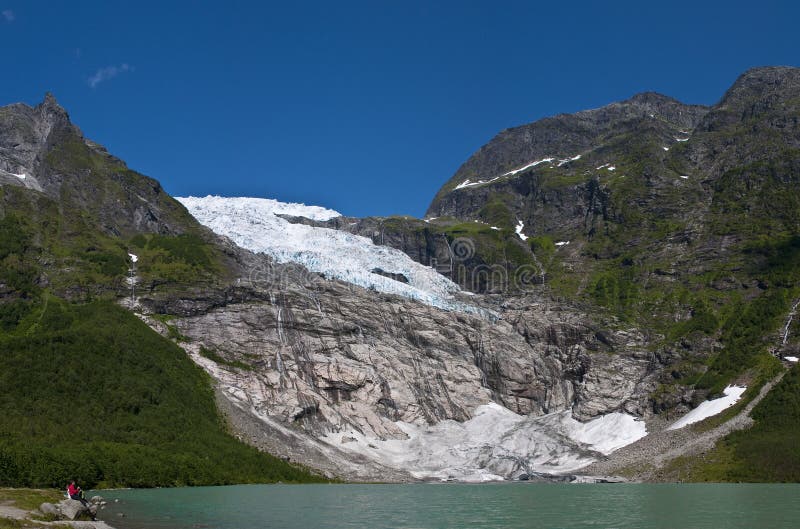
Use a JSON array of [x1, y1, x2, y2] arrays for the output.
[[0, 95, 319, 488]]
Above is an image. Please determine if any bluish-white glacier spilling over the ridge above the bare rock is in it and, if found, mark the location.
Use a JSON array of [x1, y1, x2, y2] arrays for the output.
[[178, 196, 477, 311]]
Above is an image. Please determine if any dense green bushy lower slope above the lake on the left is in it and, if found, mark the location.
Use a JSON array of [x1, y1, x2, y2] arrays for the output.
[[0, 297, 324, 486]]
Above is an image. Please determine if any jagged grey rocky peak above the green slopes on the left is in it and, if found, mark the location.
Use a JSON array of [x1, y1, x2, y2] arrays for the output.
[[0, 92, 206, 235]]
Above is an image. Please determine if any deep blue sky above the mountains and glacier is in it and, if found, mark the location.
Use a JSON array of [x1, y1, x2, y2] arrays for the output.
[[0, 0, 800, 216]]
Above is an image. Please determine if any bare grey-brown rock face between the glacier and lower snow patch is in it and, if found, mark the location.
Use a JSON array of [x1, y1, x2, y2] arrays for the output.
[[142, 256, 654, 479]]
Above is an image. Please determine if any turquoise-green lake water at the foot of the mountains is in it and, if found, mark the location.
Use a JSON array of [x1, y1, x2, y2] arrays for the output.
[[100, 483, 800, 529]]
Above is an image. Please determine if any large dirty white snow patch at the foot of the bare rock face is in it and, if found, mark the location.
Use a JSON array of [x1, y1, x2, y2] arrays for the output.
[[325, 402, 647, 482]]
